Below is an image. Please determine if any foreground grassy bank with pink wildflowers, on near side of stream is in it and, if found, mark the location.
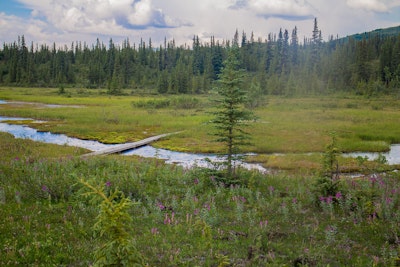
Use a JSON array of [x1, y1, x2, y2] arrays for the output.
[[0, 133, 400, 266]]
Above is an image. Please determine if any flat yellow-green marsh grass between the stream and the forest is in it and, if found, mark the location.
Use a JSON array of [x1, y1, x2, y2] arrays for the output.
[[0, 87, 400, 172]]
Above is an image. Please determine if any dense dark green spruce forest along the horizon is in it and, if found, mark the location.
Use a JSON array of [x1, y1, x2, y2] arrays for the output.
[[0, 19, 400, 96]]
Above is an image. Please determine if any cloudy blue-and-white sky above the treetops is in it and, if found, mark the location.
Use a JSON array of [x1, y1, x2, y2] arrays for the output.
[[0, 0, 400, 45]]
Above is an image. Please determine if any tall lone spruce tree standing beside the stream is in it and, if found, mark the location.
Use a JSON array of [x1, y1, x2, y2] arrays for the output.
[[212, 45, 253, 180]]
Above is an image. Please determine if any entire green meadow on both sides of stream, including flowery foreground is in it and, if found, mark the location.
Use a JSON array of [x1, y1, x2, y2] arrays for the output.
[[0, 87, 400, 266]]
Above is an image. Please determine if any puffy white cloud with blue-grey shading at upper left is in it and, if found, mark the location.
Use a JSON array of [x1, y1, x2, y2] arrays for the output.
[[15, 0, 181, 34]]
